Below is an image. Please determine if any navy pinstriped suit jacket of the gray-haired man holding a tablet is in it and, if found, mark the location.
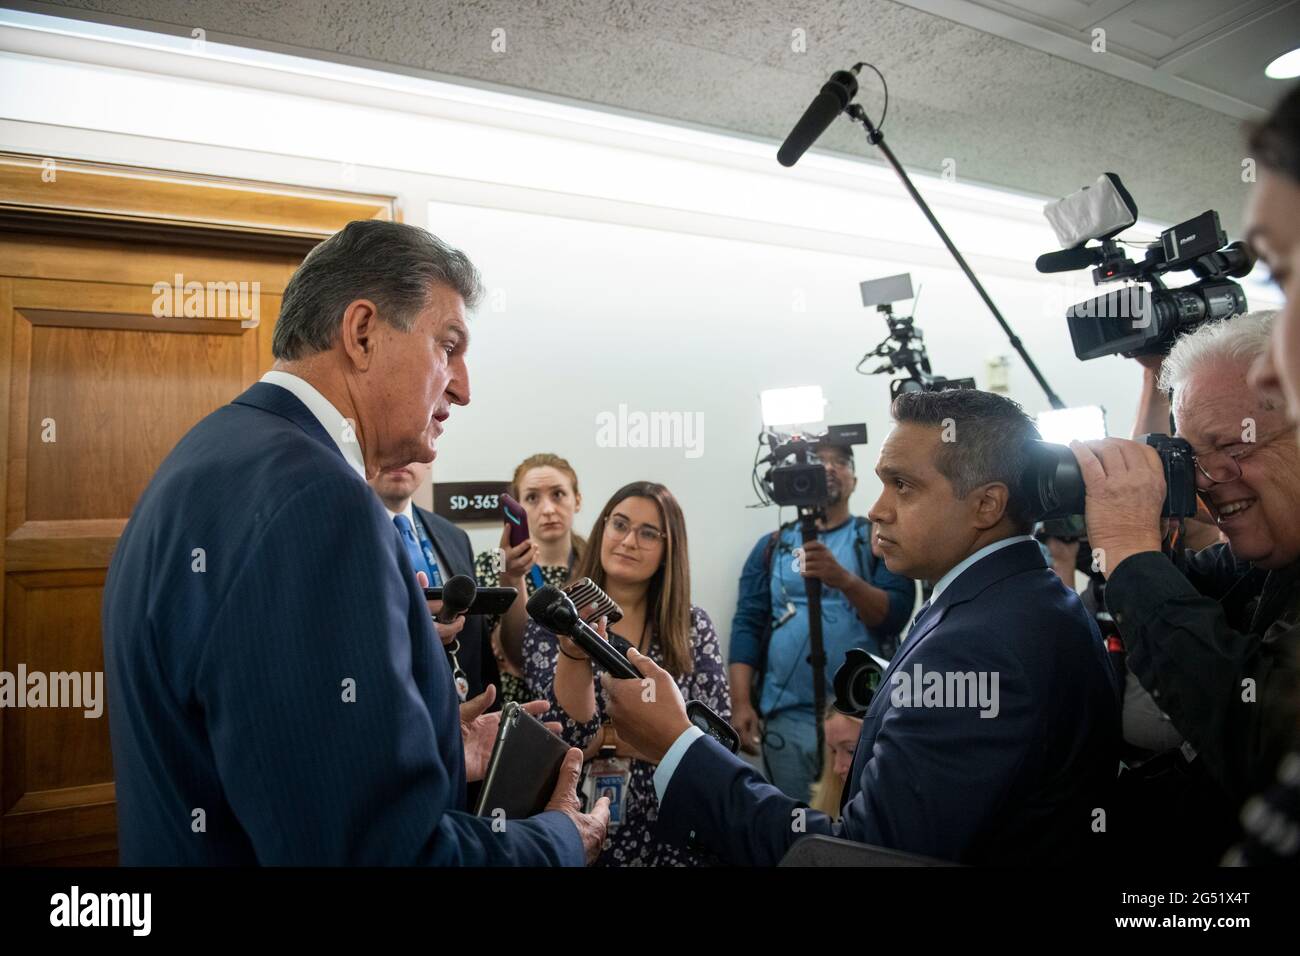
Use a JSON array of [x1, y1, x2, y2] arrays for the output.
[[104, 382, 582, 865]]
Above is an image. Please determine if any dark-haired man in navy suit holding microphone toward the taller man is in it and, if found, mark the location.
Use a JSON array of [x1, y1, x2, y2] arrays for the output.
[[606, 390, 1119, 865]]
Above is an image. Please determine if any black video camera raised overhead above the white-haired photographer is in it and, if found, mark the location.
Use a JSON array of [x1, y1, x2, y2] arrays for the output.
[[1035, 173, 1255, 360]]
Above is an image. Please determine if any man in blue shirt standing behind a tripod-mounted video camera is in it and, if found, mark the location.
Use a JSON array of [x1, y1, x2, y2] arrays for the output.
[[729, 445, 915, 800]]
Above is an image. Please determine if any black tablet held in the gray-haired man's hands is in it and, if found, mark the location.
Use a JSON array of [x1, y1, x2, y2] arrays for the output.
[[475, 701, 569, 819]]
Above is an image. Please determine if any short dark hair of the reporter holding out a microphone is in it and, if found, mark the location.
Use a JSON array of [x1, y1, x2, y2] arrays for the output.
[[889, 389, 1041, 531]]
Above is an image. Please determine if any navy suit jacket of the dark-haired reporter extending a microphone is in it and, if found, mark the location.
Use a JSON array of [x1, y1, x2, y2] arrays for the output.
[[659, 542, 1119, 865]]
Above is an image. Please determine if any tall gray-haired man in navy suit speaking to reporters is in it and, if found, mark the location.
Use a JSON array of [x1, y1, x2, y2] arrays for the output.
[[104, 221, 607, 865]]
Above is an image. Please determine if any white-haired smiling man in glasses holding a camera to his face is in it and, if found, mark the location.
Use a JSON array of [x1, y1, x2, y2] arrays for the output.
[[1071, 312, 1300, 805]]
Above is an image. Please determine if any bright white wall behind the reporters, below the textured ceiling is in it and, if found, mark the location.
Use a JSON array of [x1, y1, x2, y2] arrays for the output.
[[0, 10, 1275, 635]]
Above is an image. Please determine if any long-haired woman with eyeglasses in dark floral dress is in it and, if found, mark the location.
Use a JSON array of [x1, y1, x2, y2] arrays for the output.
[[524, 481, 731, 866]]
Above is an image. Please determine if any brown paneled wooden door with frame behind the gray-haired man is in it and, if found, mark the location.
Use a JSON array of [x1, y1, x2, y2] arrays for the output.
[[0, 151, 391, 865]]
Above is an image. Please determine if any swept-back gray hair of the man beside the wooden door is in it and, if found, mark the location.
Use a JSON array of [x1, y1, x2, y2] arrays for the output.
[[270, 219, 482, 362]]
